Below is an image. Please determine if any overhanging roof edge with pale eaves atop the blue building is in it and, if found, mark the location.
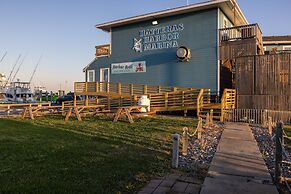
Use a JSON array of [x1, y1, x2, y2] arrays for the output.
[[96, 0, 248, 32]]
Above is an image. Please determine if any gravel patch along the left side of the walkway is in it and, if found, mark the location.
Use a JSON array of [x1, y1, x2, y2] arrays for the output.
[[179, 123, 223, 177]]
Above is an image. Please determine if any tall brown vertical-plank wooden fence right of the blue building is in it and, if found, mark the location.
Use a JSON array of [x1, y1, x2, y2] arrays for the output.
[[235, 53, 291, 111]]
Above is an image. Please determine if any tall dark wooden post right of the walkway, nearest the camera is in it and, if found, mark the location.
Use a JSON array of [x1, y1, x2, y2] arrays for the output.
[[275, 122, 283, 182]]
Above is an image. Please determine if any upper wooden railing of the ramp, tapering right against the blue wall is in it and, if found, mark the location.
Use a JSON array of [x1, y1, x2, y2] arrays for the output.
[[74, 82, 192, 96]]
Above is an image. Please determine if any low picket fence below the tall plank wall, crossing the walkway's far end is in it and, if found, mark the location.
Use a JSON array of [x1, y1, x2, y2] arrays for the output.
[[224, 109, 291, 125]]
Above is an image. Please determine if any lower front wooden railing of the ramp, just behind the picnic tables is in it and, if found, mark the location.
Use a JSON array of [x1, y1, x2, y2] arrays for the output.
[[68, 89, 210, 111]]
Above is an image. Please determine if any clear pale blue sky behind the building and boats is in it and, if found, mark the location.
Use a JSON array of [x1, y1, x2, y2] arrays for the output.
[[0, 0, 291, 91]]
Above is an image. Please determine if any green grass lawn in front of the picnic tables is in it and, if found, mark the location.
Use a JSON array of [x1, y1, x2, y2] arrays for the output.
[[0, 116, 196, 194]]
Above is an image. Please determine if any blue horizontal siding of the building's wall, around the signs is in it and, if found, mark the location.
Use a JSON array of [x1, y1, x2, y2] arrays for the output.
[[88, 9, 218, 91]]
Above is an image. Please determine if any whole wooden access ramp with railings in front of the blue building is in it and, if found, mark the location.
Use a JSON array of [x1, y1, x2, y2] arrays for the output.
[[73, 82, 235, 118]]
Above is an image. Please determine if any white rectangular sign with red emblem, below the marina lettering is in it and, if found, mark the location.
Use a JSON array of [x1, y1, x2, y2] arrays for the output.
[[111, 61, 146, 74]]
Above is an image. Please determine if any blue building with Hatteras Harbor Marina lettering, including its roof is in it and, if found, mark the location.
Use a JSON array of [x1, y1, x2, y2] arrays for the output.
[[83, 0, 248, 94]]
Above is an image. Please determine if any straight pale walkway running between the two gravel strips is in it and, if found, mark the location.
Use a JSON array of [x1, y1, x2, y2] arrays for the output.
[[200, 123, 278, 194]]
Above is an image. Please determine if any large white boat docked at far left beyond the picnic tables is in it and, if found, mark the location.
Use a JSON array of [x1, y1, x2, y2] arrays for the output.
[[5, 81, 35, 103]]
